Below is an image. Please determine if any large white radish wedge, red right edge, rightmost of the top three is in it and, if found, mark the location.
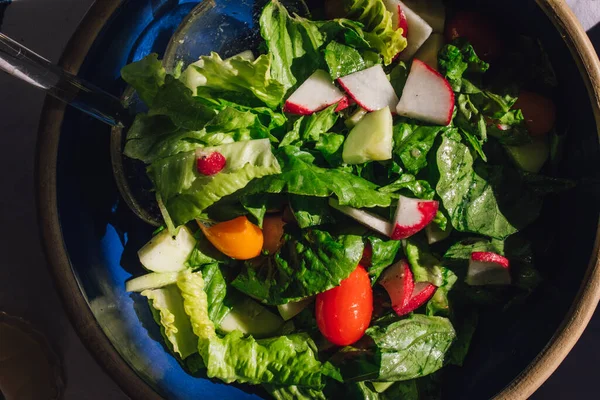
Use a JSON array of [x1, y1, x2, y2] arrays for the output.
[[396, 59, 454, 125]]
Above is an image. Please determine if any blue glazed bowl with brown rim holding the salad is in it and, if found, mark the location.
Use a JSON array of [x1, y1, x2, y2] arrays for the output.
[[37, 0, 600, 399]]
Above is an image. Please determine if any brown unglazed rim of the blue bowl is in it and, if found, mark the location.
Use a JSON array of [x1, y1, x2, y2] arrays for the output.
[[35, 0, 600, 400]]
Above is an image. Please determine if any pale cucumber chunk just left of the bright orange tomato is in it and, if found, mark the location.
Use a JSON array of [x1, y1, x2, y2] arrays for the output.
[[138, 226, 196, 272]]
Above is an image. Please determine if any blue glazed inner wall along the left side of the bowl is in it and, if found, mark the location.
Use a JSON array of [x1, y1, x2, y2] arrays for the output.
[[57, 0, 270, 399]]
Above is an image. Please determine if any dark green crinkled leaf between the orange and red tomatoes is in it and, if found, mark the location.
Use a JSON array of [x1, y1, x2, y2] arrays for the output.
[[231, 230, 364, 305]]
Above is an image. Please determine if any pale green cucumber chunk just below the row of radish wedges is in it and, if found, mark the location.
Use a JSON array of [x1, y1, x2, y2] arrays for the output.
[[342, 107, 393, 164]]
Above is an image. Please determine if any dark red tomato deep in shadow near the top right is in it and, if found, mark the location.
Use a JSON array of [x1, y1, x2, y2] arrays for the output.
[[445, 11, 503, 61]]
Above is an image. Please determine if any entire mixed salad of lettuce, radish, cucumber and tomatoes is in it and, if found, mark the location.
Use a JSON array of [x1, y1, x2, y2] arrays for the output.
[[122, 0, 572, 399]]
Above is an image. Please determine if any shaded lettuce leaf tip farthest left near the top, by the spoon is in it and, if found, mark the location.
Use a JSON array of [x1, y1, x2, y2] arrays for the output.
[[121, 53, 167, 107]]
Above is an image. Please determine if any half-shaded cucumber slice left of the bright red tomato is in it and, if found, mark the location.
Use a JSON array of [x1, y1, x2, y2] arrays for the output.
[[219, 298, 284, 338]]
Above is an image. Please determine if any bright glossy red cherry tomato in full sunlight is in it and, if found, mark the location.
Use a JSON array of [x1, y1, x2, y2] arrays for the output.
[[315, 265, 373, 346]]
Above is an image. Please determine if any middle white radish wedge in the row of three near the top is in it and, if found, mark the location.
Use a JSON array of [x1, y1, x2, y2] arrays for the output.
[[338, 64, 398, 111]]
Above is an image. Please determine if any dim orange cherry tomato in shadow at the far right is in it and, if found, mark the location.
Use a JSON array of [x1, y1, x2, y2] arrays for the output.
[[513, 90, 556, 136]]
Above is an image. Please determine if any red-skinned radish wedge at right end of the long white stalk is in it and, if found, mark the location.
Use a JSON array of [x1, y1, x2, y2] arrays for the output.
[[391, 196, 439, 240]]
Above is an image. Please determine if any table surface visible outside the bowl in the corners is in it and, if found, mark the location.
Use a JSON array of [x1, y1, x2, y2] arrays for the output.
[[0, 0, 600, 400]]
